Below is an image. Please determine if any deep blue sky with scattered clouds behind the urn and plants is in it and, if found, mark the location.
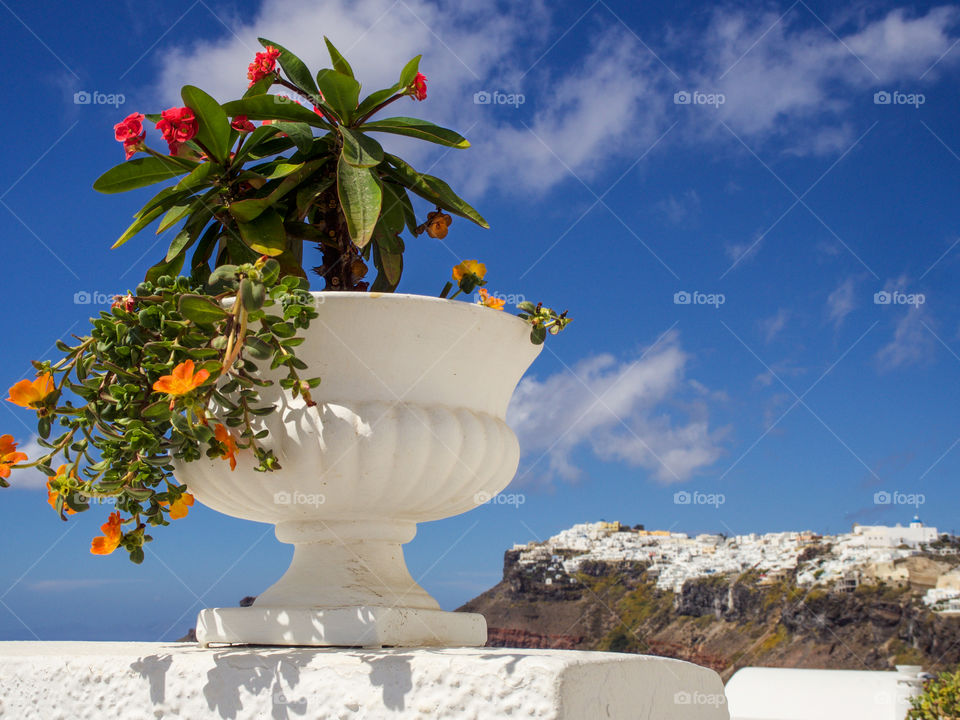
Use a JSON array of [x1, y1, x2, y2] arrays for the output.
[[0, 0, 960, 640]]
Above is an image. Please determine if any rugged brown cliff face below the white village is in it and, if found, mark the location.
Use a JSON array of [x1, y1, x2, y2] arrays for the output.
[[460, 551, 960, 678]]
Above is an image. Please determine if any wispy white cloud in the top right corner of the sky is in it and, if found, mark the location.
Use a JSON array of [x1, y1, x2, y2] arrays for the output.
[[695, 6, 960, 154]]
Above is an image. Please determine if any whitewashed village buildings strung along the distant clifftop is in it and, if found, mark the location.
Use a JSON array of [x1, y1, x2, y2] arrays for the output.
[[513, 517, 960, 614]]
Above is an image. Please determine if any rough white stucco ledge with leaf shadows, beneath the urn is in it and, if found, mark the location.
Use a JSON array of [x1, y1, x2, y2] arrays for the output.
[[0, 642, 729, 720]]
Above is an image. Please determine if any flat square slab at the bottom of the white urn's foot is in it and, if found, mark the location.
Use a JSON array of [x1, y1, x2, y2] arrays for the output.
[[197, 605, 487, 648]]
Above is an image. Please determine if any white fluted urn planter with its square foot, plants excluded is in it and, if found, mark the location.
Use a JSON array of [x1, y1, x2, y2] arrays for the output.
[[176, 293, 540, 647]]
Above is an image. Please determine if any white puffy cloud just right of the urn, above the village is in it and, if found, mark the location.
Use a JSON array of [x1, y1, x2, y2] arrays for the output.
[[507, 333, 724, 482]]
